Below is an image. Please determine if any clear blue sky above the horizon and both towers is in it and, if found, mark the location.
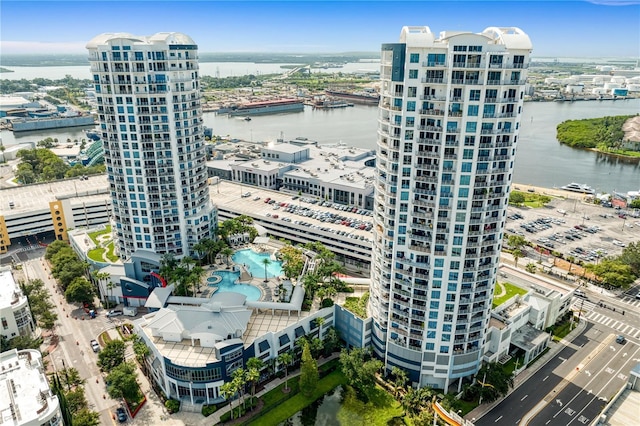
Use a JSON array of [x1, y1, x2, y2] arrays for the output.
[[0, 0, 640, 57]]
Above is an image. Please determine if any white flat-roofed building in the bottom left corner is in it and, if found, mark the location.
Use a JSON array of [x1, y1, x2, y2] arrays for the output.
[[0, 349, 64, 426]]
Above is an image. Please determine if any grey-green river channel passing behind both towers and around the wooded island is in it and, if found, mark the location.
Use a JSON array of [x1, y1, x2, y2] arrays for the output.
[[1, 95, 640, 192]]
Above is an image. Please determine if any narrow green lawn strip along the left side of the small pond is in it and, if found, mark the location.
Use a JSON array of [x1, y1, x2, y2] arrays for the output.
[[247, 370, 346, 426]]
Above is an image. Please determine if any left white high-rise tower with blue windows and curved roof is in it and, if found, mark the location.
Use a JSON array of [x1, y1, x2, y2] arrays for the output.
[[87, 33, 215, 259]]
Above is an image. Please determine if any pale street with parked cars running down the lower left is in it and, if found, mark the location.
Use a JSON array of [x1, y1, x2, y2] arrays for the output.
[[23, 257, 119, 425]]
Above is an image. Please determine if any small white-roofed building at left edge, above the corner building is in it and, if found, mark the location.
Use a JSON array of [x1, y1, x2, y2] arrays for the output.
[[0, 266, 35, 340]]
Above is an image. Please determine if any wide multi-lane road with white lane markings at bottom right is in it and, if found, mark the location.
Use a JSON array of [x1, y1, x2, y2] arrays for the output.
[[475, 267, 640, 426]]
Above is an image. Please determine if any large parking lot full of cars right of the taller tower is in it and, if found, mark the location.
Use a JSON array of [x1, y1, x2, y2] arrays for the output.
[[505, 199, 640, 263]]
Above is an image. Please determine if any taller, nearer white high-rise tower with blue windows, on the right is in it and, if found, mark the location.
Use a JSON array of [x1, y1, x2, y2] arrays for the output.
[[370, 27, 532, 389]]
